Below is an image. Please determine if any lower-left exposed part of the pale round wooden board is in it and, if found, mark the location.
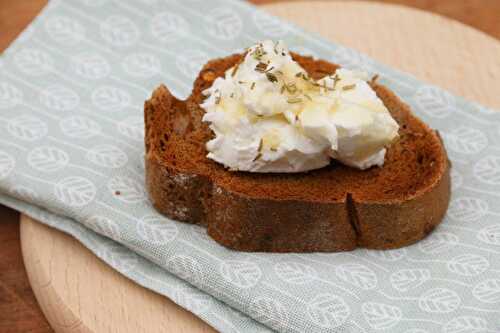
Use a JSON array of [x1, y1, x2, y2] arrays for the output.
[[21, 215, 215, 333]]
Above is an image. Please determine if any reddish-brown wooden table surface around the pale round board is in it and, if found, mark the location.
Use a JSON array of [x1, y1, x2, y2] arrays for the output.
[[0, 0, 500, 332]]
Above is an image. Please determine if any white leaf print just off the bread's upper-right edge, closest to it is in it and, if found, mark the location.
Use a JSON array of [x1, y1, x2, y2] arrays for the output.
[[415, 86, 454, 119]]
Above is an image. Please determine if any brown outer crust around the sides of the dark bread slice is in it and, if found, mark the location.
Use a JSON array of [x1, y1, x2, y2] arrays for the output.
[[144, 54, 450, 252]]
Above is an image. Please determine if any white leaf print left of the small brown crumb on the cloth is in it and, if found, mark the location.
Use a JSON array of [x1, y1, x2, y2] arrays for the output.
[[54, 176, 96, 207]]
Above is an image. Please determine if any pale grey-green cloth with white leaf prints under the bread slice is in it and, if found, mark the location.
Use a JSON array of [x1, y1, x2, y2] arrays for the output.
[[0, 0, 500, 333]]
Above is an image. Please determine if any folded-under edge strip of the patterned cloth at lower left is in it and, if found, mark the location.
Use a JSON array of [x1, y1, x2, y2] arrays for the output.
[[0, 193, 272, 332]]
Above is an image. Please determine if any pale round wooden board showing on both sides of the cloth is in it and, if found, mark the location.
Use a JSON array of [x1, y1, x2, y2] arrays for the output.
[[21, 2, 500, 333]]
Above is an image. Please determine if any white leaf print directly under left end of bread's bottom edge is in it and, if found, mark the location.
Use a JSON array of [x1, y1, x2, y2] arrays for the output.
[[220, 260, 262, 289]]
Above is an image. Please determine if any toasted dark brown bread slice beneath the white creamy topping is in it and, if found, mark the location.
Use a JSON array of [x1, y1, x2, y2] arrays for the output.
[[144, 54, 450, 252]]
